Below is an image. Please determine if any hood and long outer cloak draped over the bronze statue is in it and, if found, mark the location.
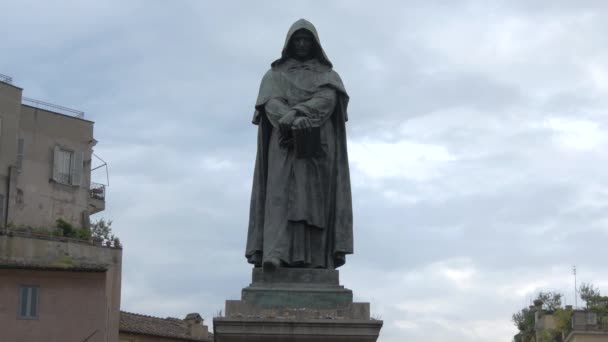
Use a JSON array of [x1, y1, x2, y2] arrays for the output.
[[245, 19, 353, 267]]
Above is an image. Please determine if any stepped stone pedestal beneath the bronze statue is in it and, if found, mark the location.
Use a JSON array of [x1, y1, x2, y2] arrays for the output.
[[213, 268, 382, 342]]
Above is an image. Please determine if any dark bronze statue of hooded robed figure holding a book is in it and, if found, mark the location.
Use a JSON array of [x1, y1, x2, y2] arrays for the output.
[[245, 19, 353, 269]]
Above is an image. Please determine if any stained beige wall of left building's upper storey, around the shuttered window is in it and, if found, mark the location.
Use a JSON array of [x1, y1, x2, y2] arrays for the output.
[[0, 82, 103, 227]]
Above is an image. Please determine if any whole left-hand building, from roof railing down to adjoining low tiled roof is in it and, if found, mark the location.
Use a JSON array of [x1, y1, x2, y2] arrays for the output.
[[0, 74, 213, 342]]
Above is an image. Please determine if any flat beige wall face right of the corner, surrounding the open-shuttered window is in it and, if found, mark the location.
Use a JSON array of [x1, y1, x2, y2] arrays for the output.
[[9, 105, 94, 227]]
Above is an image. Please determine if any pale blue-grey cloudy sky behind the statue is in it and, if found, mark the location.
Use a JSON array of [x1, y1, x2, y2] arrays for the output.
[[0, 0, 608, 342]]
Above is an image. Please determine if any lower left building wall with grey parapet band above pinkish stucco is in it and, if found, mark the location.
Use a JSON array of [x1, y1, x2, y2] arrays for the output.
[[0, 235, 122, 342]]
